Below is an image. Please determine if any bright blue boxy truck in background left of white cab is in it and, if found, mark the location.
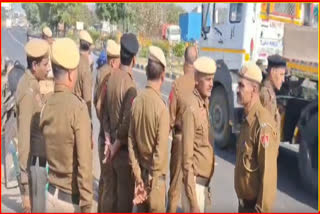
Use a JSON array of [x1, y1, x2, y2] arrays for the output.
[[179, 12, 201, 42]]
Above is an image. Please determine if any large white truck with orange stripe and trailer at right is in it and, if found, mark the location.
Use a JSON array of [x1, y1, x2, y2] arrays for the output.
[[199, 3, 319, 195]]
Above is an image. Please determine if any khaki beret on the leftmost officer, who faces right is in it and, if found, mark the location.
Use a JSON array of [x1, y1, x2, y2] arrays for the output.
[[24, 39, 49, 58]]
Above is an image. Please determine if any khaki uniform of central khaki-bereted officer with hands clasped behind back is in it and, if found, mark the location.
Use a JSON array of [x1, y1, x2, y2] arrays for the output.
[[128, 85, 169, 213]]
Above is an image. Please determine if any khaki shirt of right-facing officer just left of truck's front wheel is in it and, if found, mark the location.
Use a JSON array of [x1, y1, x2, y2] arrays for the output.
[[182, 88, 215, 207]]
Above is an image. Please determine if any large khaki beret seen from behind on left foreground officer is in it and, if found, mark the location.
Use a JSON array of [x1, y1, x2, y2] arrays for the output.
[[51, 38, 80, 69]]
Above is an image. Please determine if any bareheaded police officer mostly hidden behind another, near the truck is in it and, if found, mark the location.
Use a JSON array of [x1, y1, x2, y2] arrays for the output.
[[168, 46, 198, 213]]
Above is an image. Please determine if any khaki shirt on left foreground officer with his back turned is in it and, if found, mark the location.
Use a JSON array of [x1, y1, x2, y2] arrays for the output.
[[40, 85, 93, 211]]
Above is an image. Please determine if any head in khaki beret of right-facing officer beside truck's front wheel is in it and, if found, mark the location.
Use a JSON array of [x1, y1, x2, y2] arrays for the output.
[[193, 56, 217, 98]]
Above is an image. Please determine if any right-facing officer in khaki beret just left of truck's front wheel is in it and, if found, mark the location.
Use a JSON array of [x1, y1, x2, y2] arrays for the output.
[[182, 57, 216, 212]]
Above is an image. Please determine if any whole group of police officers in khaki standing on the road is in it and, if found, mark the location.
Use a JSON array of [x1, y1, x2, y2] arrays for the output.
[[16, 25, 286, 212]]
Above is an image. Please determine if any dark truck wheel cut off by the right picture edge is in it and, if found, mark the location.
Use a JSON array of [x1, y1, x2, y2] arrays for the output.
[[298, 140, 318, 195]]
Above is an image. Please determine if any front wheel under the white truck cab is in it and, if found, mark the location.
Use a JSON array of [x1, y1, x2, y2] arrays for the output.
[[210, 86, 231, 149]]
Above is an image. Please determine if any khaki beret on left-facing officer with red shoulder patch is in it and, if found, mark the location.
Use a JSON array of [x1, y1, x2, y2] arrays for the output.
[[239, 61, 262, 83]]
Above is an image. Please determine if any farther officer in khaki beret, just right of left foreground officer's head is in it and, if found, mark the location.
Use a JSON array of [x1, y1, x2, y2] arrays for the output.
[[74, 30, 93, 118]]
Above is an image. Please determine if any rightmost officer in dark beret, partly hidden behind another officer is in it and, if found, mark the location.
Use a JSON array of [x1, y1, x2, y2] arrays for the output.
[[260, 54, 286, 134]]
